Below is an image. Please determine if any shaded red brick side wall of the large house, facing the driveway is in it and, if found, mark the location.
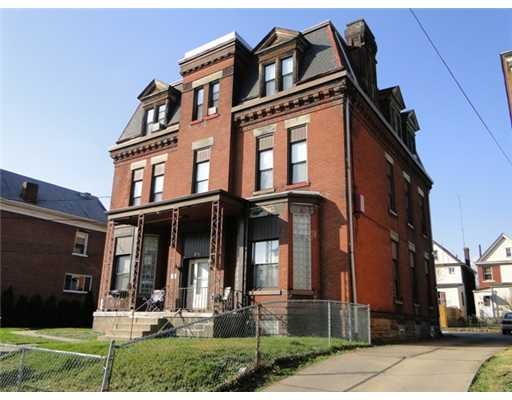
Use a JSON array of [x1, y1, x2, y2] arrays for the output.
[[351, 104, 436, 322]]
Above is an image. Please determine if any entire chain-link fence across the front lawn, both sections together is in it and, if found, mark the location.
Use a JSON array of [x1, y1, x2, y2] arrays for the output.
[[0, 300, 371, 392]]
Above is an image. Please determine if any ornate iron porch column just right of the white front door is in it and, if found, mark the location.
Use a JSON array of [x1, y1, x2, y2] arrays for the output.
[[209, 200, 224, 308]]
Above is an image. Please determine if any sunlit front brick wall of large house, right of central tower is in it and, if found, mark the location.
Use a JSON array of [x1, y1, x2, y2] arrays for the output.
[[234, 103, 350, 301]]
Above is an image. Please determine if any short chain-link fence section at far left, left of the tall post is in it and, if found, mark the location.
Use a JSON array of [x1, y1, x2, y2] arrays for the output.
[[0, 346, 107, 392]]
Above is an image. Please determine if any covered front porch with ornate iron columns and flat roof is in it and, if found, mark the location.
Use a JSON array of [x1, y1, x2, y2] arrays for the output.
[[95, 190, 249, 320]]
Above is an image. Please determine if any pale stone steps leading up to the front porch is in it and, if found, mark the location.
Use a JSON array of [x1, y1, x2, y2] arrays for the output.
[[100, 317, 167, 340]]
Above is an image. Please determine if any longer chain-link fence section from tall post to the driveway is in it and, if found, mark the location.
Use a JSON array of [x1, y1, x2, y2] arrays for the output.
[[109, 300, 371, 391]]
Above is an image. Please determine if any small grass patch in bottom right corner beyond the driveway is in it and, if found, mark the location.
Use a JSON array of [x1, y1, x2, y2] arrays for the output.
[[469, 348, 512, 392]]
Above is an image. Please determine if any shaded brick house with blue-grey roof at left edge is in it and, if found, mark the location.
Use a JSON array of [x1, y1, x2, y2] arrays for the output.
[[0, 170, 106, 325]]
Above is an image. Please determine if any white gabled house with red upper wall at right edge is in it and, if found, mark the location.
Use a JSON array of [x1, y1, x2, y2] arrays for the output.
[[474, 233, 512, 319]]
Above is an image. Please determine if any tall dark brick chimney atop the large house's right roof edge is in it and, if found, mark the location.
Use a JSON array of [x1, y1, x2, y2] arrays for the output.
[[345, 19, 377, 101]]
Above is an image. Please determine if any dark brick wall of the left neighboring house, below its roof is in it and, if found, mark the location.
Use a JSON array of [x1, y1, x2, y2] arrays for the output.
[[0, 211, 105, 300]]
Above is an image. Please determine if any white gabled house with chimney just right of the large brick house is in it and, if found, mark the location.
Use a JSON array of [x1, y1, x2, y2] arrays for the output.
[[434, 241, 475, 323]]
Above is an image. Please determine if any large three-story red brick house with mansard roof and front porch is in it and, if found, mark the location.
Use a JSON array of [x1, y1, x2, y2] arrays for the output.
[[94, 20, 438, 337]]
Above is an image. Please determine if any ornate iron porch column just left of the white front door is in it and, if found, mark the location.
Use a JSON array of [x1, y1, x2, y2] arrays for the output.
[[165, 208, 180, 310]]
